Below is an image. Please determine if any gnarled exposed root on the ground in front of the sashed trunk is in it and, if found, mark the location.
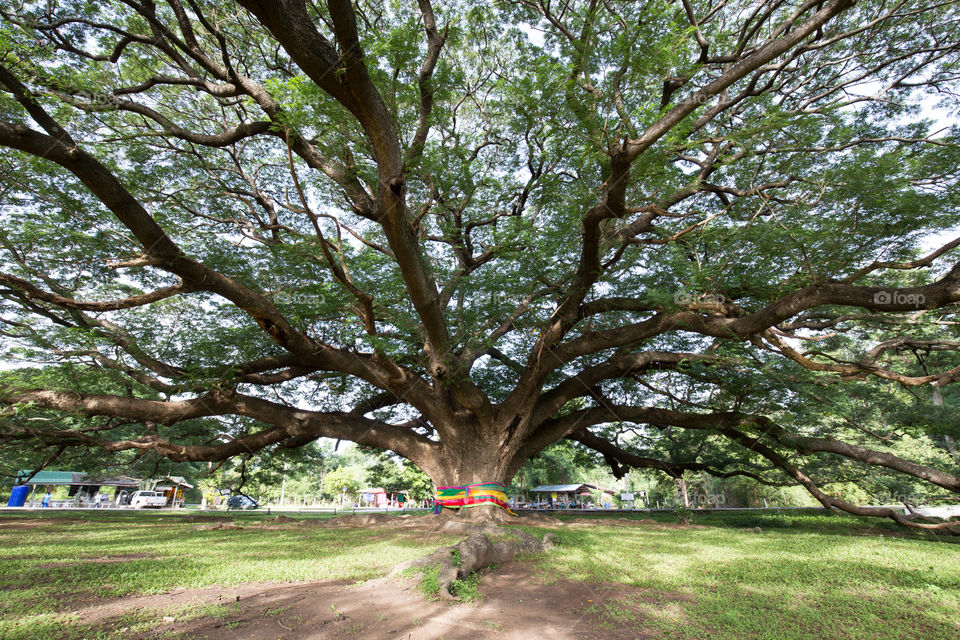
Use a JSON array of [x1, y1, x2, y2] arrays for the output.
[[388, 522, 553, 600]]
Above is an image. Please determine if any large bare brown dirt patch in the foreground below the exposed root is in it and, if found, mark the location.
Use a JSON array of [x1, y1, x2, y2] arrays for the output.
[[75, 562, 668, 640]]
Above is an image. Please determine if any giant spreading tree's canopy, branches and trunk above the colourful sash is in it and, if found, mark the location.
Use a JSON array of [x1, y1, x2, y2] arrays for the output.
[[0, 0, 960, 526]]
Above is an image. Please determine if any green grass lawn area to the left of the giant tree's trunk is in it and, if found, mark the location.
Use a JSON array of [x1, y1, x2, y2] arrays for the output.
[[0, 512, 458, 640]]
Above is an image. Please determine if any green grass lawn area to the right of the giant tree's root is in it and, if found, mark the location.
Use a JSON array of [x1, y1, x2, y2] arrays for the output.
[[528, 515, 960, 640]]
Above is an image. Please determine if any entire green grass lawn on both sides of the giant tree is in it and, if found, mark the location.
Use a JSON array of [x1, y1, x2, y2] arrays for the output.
[[0, 513, 960, 640]]
